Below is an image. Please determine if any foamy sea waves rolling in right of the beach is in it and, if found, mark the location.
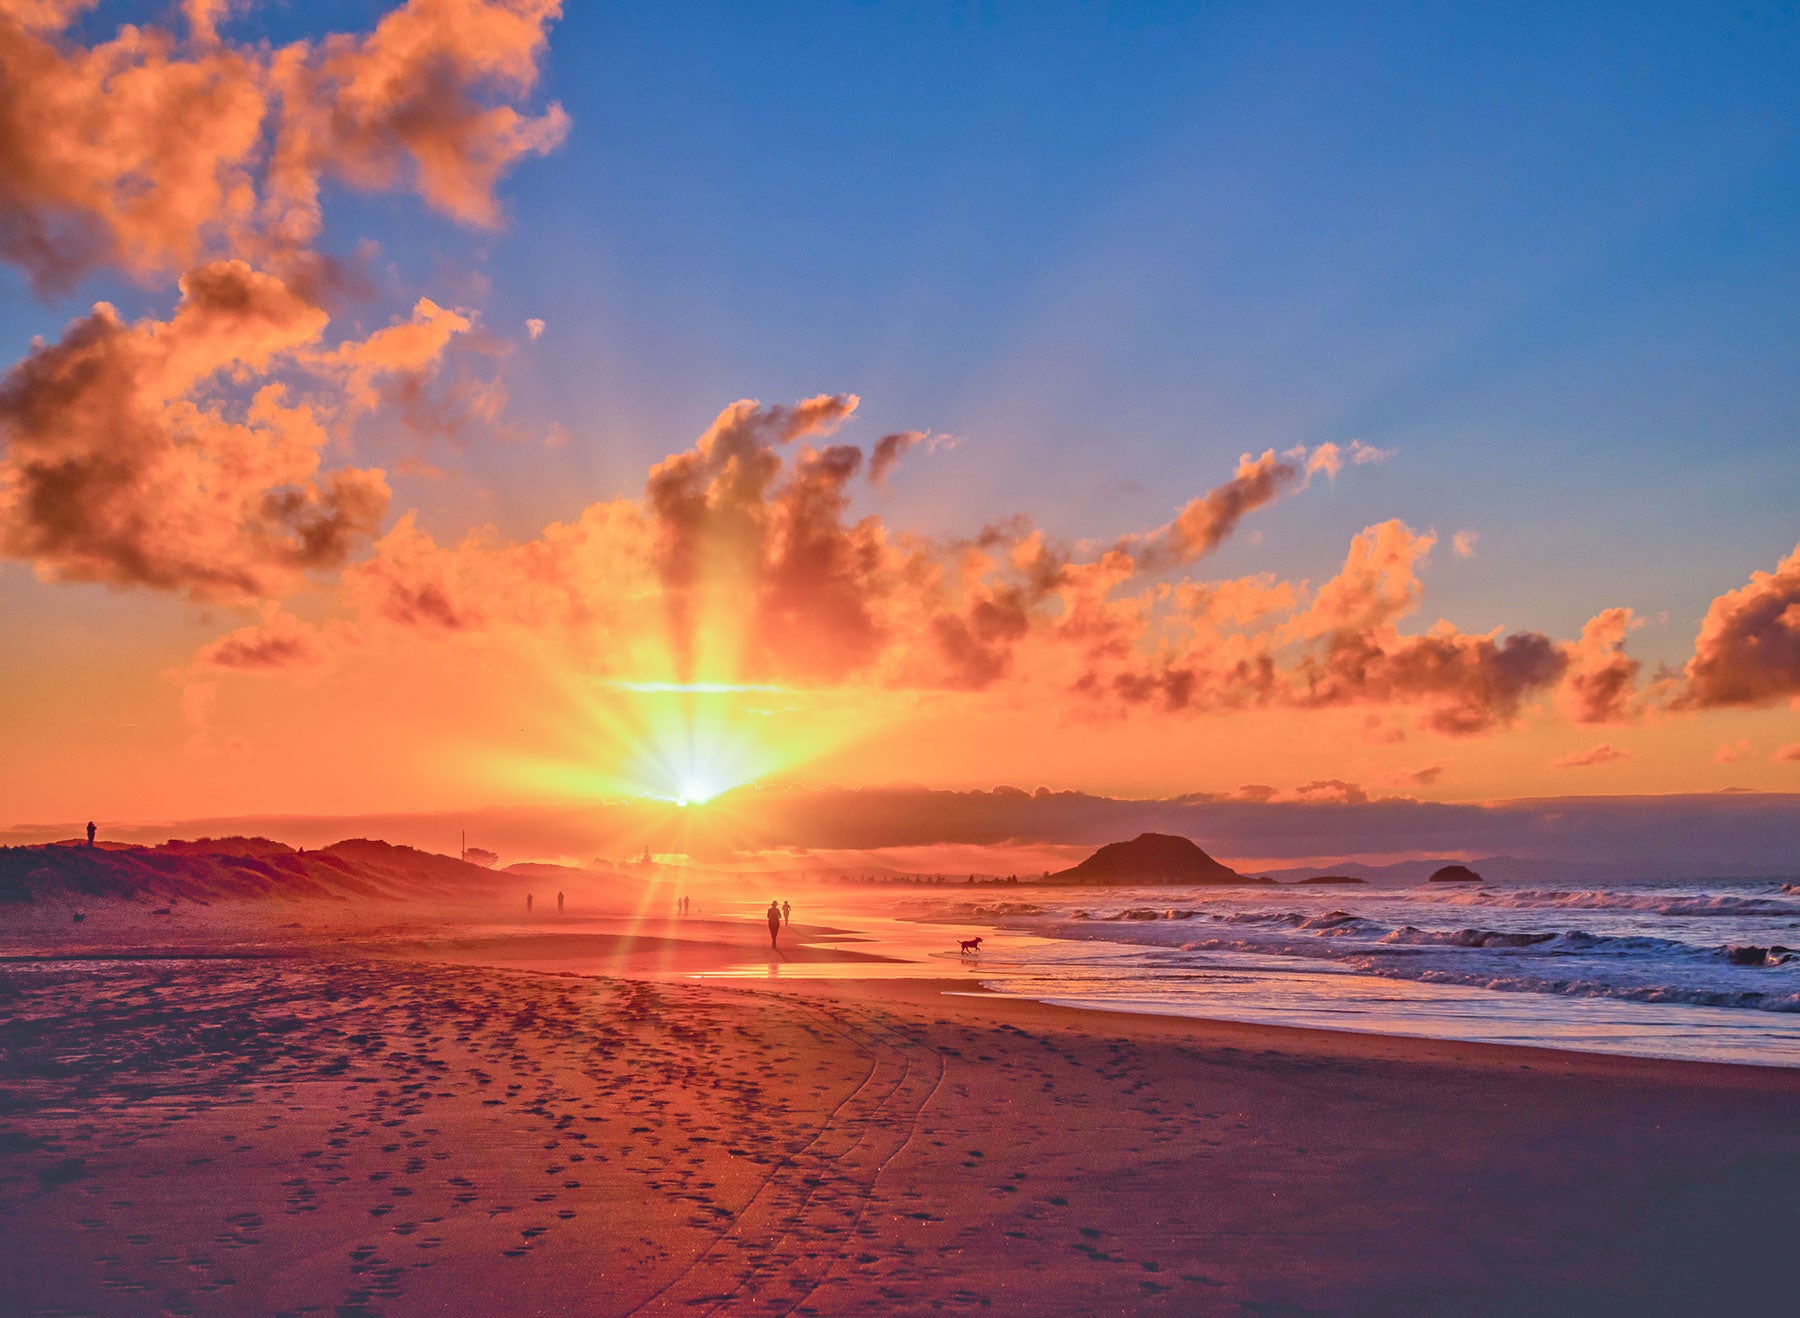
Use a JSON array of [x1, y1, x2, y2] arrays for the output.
[[914, 879, 1800, 1066]]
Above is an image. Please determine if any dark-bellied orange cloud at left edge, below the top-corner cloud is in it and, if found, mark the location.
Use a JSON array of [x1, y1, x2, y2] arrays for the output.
[[0, 261, 389, 600]]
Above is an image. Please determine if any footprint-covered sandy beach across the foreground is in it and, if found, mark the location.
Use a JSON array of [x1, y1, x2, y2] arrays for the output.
[[0, 922, 1800, 1314]]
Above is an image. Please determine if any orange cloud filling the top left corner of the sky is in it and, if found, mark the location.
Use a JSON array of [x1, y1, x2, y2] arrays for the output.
[[0, 0, 567, 290]]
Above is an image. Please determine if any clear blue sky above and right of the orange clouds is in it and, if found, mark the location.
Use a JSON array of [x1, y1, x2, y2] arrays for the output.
[[496, 4, 1800, 646]]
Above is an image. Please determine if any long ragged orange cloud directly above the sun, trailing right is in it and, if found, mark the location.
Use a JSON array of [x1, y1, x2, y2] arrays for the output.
[[257, 394, 1605, 741]]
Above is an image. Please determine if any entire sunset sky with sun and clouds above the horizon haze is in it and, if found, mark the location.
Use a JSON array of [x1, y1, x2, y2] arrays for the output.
[[0, 0, 1800, 843]]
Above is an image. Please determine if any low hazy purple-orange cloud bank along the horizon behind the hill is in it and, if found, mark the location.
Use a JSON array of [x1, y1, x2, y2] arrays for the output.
[[0, 783, 1800, 882]]
